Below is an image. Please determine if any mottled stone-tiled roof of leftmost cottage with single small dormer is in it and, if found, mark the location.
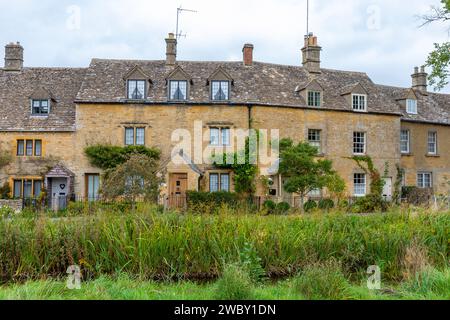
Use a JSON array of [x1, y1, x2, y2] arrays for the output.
[[0, 68, 86, 131]]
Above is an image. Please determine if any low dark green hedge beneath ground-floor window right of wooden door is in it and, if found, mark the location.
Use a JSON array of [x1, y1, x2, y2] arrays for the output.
[[187, 191, 239, 208]]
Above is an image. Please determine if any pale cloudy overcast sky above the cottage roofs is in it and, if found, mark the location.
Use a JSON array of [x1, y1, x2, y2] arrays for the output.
[[0, 0, 450, 92]]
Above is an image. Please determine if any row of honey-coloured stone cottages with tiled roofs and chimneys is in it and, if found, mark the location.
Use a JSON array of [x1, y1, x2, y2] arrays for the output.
[[0, 32, 450, 202]]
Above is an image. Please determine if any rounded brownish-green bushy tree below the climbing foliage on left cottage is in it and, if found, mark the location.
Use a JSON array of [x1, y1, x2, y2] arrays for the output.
[[100, 154, 162, 207]]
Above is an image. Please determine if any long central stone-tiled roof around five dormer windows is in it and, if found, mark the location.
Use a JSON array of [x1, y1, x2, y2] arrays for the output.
[[77, 59, 400, 115]]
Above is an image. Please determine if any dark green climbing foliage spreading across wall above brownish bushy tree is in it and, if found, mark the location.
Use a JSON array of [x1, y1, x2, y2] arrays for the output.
[[84, 145, 161, 170]]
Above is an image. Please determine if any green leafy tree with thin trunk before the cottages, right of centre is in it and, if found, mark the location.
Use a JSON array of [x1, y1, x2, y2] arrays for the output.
[[279, 139, 336, 211]]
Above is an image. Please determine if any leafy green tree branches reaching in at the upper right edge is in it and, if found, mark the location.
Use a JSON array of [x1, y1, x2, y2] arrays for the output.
[[422, 0, 450, 90]]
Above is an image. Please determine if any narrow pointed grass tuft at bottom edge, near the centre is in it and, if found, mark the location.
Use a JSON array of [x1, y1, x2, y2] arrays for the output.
[[215, 264, 254, 300]]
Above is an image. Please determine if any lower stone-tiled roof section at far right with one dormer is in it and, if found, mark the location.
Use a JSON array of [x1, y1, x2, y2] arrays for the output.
[[378, 85, 450, 125]]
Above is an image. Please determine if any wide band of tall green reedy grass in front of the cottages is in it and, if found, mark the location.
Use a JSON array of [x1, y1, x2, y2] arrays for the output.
[[0, 209, 450, 282]]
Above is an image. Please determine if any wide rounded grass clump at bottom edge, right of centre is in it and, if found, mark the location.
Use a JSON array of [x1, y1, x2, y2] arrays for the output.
[[294, 262, 350, 300]]
